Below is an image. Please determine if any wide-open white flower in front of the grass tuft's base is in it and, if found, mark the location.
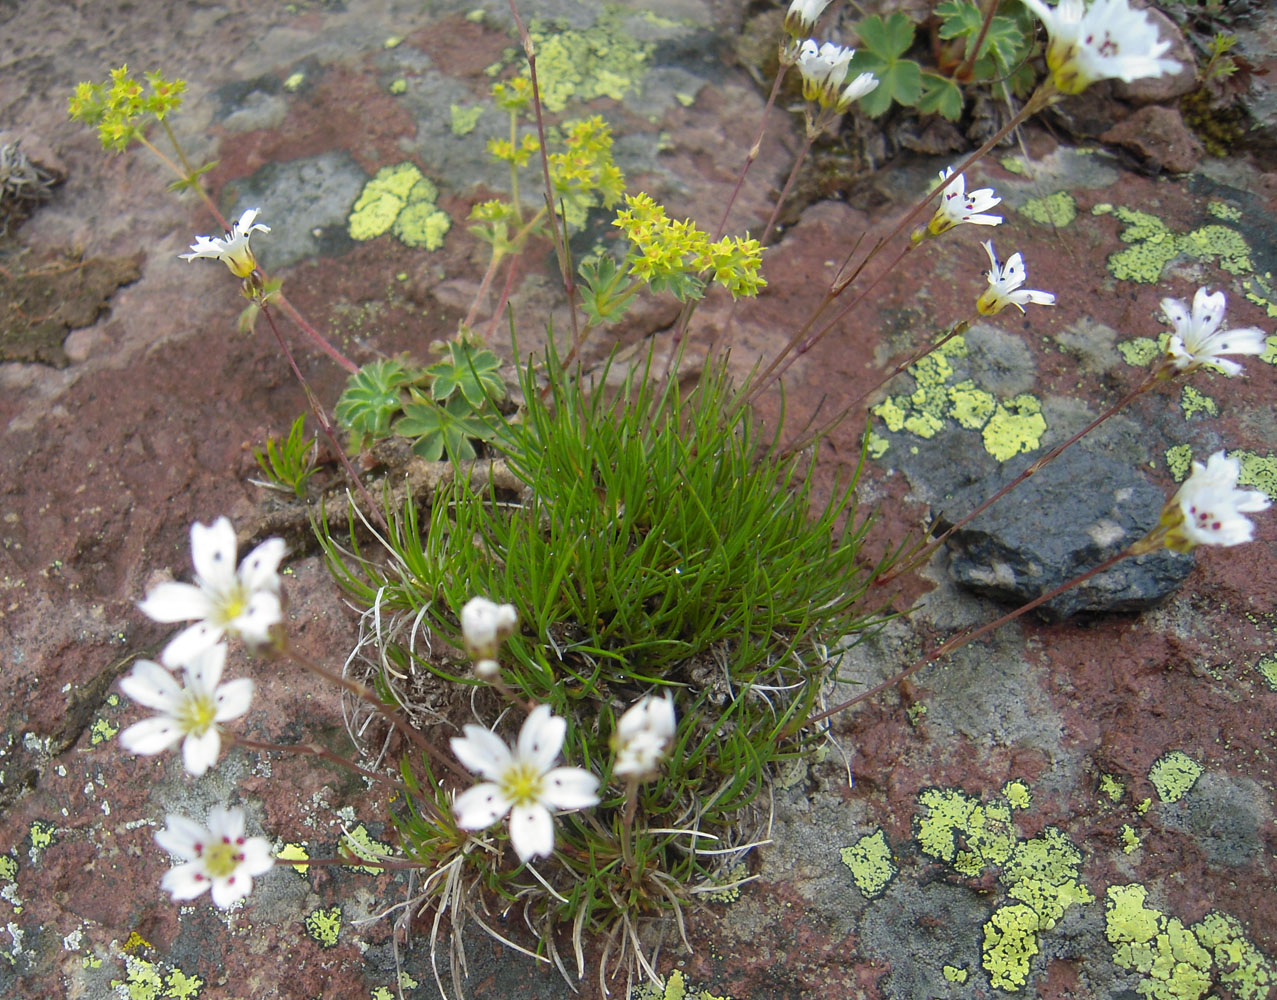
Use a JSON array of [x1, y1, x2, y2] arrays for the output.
[[452, 705, 599, 861]]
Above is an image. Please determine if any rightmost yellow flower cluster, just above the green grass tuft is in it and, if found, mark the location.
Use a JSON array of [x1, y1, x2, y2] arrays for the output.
[[613, 194, 766, 300]]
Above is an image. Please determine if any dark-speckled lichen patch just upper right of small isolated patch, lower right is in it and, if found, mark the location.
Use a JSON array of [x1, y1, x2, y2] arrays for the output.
[[914, 788, 1015, 879]]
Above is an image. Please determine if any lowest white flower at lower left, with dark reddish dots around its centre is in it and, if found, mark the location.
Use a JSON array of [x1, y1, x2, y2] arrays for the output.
[[156, 806, 275, 909]]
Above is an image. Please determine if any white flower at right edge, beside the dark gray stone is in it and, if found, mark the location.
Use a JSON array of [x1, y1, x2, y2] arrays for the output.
[[1161, 451, 1269, 552]]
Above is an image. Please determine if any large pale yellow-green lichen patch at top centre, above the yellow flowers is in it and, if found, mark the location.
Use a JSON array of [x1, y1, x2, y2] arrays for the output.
[[531, 4, 654, 112]]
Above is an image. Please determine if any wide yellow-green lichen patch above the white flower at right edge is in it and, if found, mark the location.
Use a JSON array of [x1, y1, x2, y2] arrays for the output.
[[1091, 204, 1254, 285]]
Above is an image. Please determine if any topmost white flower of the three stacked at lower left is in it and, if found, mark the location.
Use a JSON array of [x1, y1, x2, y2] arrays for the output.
[[138, 517, 285, 667]]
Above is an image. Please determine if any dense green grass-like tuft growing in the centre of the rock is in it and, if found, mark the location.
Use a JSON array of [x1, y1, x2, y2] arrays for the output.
[[321, 352, 899, 991]]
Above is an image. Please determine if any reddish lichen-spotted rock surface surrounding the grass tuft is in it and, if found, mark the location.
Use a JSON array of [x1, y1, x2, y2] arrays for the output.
[[0, 0, 1277, 1000]]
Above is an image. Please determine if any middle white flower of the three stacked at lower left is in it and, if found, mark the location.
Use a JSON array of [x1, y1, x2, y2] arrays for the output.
[[120, 642, 253, 778]]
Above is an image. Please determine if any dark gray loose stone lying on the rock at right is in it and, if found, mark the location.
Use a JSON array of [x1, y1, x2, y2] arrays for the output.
[[941, 447, 1193, 622]]
